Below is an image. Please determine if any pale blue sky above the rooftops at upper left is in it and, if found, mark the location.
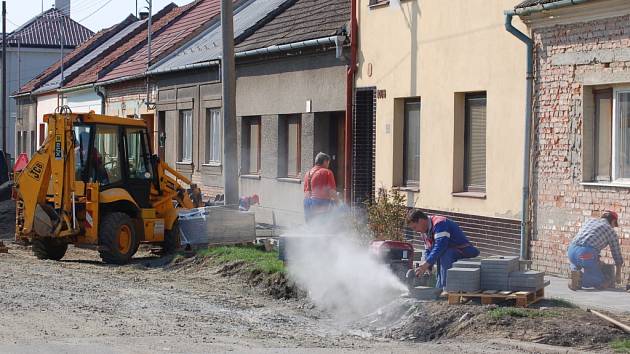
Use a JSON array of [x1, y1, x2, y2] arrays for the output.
[[7, 0, 193, 32]]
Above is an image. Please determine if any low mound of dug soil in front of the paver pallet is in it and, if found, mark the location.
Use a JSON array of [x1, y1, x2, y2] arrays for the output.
[[362, 299, 630, 349]]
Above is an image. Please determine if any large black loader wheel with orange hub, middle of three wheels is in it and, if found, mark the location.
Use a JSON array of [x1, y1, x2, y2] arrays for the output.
[[98, 213, 138, 264]]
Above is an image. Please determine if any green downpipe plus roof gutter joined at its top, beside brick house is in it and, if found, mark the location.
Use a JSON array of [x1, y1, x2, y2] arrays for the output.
[[505, 0, 589, 260]]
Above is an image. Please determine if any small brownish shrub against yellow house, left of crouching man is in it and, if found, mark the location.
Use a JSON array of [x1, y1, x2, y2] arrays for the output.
[[366, 188, 407, 241]]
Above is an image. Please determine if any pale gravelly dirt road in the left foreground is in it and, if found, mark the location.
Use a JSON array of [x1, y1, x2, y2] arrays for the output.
[[0, 245, 616, 353]]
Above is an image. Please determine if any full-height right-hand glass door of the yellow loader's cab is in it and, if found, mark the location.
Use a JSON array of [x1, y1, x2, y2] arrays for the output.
[[123, 127, 153, 208]]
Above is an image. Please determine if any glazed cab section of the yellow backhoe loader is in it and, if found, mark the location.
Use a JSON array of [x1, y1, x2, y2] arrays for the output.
[[73, 124, 155, 208]]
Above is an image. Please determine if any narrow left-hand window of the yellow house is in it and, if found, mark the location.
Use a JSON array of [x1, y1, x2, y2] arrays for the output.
[[403, 100, 420, 187]]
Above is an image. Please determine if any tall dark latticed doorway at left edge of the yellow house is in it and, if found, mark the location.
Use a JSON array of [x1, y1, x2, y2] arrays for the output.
[[352, 88, 376, 206]]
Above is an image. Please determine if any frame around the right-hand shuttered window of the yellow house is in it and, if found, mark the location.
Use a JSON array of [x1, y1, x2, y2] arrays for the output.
[[462, 91, 488, 193]]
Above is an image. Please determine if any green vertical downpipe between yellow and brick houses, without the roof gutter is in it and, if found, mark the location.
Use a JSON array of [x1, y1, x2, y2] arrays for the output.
[[505, 13, 534, 260]]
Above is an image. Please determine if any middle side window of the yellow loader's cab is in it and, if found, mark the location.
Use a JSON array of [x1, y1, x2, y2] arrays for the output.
[[90, 125, 122, 186]]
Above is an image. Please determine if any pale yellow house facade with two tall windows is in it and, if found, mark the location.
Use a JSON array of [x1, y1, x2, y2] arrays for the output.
[[356, 0, 526, 254]]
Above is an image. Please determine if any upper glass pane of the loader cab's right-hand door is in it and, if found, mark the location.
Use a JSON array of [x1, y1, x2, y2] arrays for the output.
[[125, 128, 152, 179]]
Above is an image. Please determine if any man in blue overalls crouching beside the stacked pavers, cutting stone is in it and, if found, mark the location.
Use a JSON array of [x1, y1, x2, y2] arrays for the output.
[[407, 210, 479, 289]]
